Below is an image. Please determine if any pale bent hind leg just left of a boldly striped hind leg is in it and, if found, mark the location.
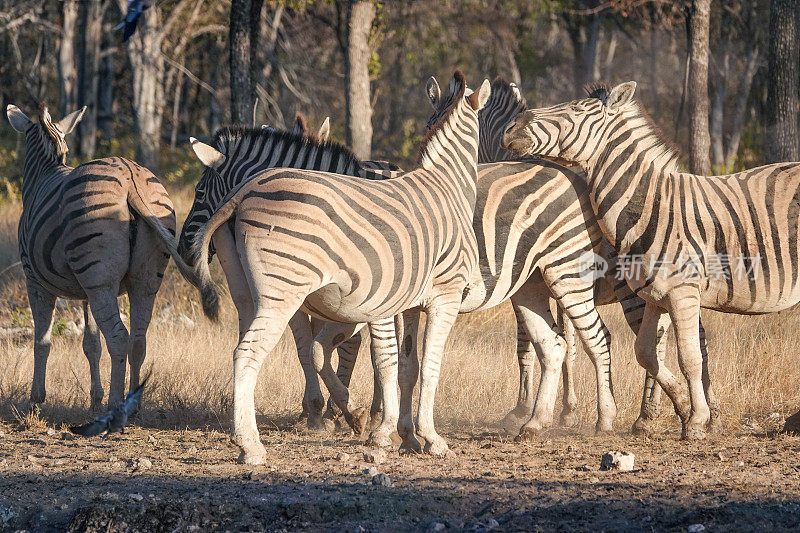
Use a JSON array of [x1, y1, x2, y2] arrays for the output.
[[511, 283, 566, 440]]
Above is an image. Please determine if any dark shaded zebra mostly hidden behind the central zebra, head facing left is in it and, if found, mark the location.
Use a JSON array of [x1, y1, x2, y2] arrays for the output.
[[178, 114, 397, 432]]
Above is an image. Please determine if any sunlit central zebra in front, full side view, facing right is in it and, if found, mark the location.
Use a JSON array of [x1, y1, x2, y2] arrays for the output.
[[186, 71, 491, 463]]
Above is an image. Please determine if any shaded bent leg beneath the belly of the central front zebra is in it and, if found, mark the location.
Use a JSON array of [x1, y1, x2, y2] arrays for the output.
[[312, 322, 369, 436]]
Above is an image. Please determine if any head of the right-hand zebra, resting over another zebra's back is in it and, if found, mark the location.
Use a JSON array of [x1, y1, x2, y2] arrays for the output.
[[502, 81, 636, 163]]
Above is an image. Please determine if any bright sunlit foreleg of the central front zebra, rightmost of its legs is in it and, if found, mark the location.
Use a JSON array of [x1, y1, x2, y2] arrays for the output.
[[416, 294, 463, 455]]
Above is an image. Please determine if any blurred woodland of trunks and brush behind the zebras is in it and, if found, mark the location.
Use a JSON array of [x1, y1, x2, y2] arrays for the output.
[[0, 0, 800, 191]]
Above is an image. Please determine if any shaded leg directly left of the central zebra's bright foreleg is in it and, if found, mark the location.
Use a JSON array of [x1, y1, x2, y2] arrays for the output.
[[397, 309, 422, 453]]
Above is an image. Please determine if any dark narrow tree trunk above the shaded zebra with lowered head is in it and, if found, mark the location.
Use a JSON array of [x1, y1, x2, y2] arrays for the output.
[[228, 0, 253, 124]]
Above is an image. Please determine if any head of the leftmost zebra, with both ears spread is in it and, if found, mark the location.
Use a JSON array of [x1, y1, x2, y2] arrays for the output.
[[6, 103, 86, 165]]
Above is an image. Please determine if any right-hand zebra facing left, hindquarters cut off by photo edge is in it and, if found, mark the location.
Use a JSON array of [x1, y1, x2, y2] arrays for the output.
[[503, 82, 800, 439]]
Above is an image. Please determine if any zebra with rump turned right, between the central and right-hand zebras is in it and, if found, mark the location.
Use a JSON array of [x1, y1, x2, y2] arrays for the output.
[[390, 78, 718, 438]]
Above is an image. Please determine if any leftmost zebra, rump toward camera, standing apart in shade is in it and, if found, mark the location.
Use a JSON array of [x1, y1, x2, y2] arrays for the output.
[[6, 105, 193, 408]]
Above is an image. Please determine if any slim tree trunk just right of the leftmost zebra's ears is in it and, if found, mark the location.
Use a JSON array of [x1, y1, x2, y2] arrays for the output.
[[77, 0, 104, 159]]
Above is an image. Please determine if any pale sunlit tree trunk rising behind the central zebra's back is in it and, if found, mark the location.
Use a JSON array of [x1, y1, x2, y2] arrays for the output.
[[344, 0, 375, 159]]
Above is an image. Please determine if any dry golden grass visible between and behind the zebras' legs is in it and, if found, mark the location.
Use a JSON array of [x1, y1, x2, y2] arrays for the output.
[[0, 188, 800, 430]]
